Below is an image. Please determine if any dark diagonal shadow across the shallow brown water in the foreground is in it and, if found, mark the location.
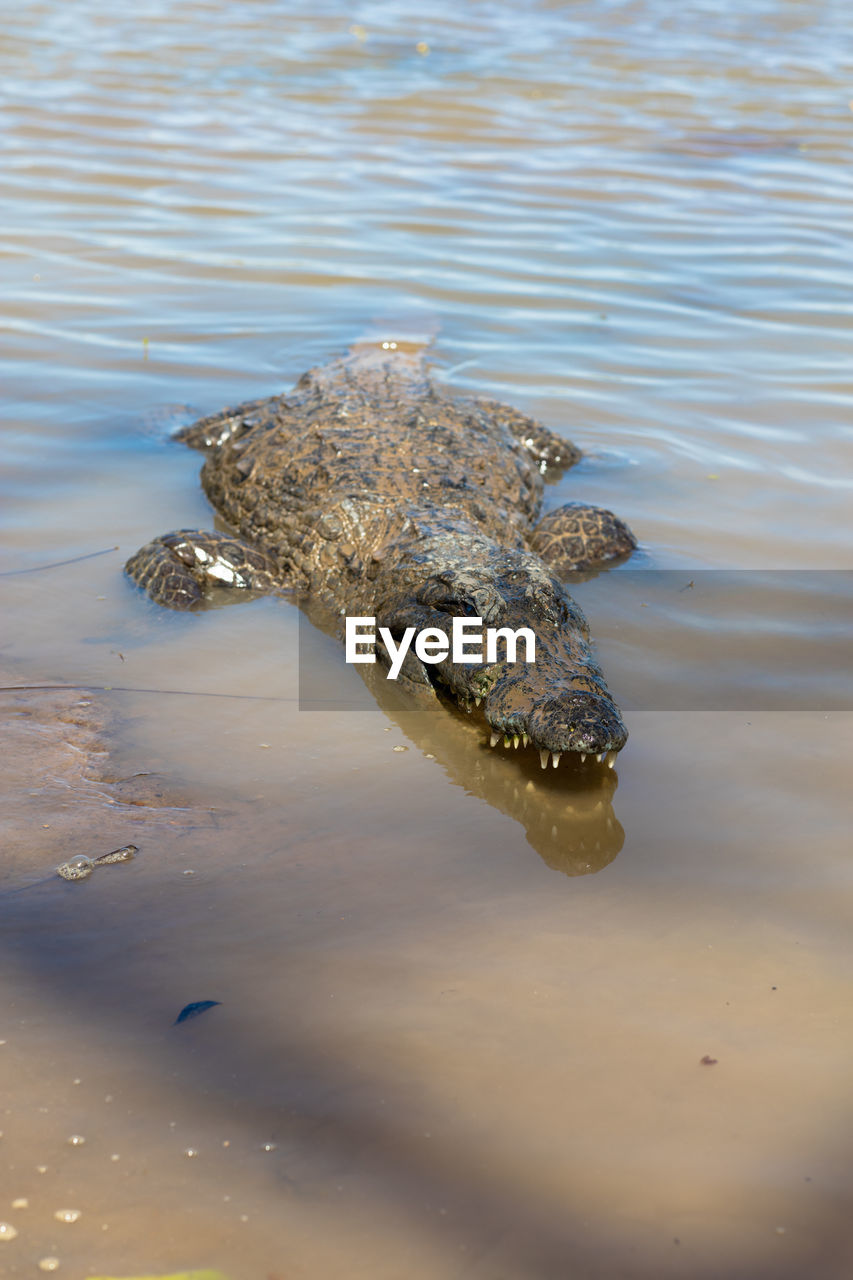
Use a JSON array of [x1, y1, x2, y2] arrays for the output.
[[0, 823, 839, 1280]]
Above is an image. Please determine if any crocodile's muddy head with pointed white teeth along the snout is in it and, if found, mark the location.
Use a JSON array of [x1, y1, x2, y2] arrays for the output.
[[378, 544, 628, 768]]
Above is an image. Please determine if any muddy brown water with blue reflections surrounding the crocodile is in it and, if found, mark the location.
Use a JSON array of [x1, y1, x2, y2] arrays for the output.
[[0, 0, 853, 1280]]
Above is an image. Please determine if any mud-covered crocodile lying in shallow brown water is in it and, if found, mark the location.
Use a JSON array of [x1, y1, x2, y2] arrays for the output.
[[126, 342, 637, 768]]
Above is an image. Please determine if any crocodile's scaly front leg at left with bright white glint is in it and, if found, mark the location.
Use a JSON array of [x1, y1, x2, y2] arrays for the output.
[[124, 529, 284, 609]]
